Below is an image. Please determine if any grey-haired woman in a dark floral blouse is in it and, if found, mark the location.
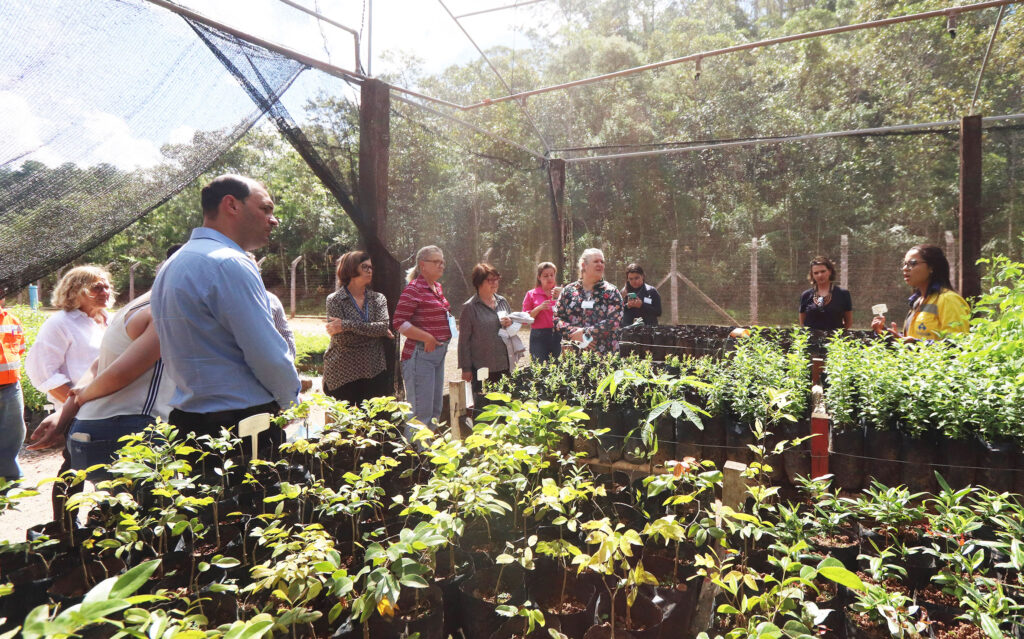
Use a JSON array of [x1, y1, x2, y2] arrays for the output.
[[555, 249, 623, 353]]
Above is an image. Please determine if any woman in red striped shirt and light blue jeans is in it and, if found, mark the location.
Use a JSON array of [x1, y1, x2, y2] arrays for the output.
[[392, 246, 455, 437]]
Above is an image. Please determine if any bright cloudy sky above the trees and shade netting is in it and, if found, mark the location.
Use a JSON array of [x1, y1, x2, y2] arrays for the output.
[[0, 0, 557, 170]]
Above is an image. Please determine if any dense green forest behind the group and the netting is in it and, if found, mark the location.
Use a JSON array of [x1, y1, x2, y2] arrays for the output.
[[0, 0, 1024, 326]]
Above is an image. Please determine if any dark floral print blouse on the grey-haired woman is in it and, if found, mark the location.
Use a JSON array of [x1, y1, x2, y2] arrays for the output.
[[555, 280, 623, 353]]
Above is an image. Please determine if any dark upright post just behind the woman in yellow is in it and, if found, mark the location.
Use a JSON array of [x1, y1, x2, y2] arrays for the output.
[[959, 116, 982, 298]]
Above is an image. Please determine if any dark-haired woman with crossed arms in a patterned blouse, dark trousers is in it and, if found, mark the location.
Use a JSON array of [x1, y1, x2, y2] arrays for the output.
[[324, 251, 394, 404]]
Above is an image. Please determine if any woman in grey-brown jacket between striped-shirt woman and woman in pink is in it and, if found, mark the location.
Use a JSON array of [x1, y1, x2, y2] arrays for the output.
[[459, 263, 513, 395]]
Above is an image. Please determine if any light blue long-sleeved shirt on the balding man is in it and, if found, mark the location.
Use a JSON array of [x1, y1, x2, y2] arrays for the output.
[[152, 227, 299, 413]]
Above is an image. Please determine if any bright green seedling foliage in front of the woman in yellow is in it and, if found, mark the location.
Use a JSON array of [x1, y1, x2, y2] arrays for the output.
[[825, 250, 1024, 442]]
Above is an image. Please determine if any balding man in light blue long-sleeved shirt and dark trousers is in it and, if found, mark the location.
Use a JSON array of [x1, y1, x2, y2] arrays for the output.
[[152, 175, 299, 452]]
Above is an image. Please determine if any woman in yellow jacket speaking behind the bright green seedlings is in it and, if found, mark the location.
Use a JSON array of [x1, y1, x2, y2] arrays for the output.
[[871, 244, 971, 341]]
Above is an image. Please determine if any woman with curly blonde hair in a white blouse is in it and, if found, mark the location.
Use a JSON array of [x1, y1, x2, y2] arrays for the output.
[[25, 265, 114, 406]]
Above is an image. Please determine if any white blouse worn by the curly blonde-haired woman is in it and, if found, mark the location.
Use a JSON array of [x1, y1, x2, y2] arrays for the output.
[[25, 309, 106, 401]]
